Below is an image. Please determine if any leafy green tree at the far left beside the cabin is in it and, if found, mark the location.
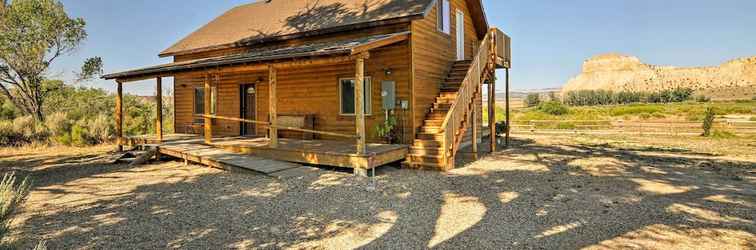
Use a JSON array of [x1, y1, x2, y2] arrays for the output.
[[0, 0, 102, 121]]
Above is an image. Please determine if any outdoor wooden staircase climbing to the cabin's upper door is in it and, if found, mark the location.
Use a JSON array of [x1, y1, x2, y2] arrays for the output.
[[404, 29, 498, 171]]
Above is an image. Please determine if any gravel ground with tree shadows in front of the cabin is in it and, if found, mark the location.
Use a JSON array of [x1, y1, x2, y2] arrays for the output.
[[0, 137, 756, 249]]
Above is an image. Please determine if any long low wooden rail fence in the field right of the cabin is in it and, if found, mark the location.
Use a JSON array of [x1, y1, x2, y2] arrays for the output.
[[512, 120, 756, 136]]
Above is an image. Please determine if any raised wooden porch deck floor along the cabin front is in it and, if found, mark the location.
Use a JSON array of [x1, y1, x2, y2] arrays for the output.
[[124, 134, 408, 171]]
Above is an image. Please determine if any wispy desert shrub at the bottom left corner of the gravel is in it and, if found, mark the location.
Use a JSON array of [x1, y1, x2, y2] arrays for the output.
[[0, 173, 30, 241]]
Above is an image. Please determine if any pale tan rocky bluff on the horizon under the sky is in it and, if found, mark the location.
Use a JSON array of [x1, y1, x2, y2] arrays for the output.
[[562, 54, 756, 99]]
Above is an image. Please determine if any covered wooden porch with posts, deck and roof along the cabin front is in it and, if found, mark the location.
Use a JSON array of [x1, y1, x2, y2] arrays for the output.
[[103, 32, 409, 174]]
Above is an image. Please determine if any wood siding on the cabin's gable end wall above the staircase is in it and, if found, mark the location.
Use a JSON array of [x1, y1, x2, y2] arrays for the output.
[[410, 0, 479, 139]]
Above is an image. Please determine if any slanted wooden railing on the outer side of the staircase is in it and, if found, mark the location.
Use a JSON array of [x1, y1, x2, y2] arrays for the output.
[[441, 29, 497, 168]]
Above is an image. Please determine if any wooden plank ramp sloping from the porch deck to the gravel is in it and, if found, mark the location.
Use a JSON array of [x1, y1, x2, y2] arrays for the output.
[[158, 142, 317, 178]]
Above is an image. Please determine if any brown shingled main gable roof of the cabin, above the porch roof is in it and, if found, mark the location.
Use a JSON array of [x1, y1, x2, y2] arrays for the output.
[[160, 0, 488, 57]]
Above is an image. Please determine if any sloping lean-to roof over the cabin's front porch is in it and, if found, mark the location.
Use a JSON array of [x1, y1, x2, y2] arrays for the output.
[[102, 31, 410, 82]]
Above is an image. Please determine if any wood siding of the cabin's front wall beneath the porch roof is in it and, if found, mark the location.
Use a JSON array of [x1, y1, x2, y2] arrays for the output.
[[175, 42, 412, 143]]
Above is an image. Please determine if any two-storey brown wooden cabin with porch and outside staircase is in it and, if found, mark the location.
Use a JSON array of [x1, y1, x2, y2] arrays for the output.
[[103, 0, 511, 173]]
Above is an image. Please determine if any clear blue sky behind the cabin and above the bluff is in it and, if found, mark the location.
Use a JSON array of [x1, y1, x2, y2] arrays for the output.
[[56, 0, 756, 95]]
